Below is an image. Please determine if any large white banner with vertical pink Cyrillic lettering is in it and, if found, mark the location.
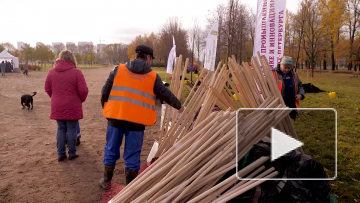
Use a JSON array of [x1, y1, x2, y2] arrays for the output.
[[253, 0, 286, 68]]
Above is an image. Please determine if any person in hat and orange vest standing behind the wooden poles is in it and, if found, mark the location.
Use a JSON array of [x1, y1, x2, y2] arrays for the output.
[[272, 56, 305, 120]]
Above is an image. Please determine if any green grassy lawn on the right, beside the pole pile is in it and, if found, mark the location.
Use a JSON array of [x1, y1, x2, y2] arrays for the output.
[[295, 72, 360, 202]]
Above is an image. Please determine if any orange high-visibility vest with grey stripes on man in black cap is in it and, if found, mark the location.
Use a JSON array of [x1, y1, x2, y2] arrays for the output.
[[103, 64, 156, 126]]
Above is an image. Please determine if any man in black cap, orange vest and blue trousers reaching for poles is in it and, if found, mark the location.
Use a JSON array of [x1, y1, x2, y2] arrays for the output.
[[100, 45, 184, 189]]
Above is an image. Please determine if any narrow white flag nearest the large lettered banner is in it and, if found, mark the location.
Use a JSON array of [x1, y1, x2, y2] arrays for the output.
[[204, 22, 219, 71]]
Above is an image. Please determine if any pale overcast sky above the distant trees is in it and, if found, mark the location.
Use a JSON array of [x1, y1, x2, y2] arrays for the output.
[[0, 0, 298, 48]]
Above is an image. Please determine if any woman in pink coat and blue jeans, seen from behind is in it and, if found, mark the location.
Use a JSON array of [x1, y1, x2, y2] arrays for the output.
[[45, 50, 89, 162]]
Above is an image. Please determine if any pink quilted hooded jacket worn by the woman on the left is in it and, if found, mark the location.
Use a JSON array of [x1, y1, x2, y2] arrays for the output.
[[45, 60, 89, 120]]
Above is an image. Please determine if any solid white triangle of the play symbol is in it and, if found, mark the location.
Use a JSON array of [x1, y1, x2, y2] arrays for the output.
[[271, 127, 304, 161]]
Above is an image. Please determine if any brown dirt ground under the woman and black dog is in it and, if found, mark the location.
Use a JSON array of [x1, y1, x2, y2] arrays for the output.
[[0, 68, 160, 202]]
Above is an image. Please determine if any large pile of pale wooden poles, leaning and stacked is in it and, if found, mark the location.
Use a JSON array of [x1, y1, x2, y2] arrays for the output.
[[111, 54, 296, 203]]
